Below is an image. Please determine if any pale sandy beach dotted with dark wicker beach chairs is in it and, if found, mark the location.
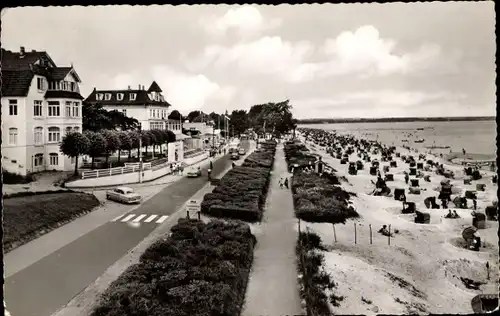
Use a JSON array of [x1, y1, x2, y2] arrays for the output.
[[299, 130, 499, 315]]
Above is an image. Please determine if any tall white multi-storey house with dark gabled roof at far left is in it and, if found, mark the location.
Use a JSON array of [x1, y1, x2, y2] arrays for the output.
[[2, 47, 83, 175]]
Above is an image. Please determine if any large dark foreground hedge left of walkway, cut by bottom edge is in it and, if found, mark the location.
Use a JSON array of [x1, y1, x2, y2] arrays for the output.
[[91, 219, 256, 316]]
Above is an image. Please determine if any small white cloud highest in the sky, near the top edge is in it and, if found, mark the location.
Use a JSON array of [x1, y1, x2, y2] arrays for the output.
[[200, 5, 281, 37]]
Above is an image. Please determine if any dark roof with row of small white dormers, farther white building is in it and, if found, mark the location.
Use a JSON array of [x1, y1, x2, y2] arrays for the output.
[[84, 89, 171, 107]]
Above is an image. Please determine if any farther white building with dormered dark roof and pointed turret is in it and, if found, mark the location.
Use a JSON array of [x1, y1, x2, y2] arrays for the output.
[[84, 81, 187, 161]]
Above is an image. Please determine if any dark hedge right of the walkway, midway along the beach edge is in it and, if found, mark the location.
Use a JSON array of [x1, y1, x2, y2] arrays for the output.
[[285, 143, 359, 224]]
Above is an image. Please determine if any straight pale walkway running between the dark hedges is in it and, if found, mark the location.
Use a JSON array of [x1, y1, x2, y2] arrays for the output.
[[242, 144, 304, 316]]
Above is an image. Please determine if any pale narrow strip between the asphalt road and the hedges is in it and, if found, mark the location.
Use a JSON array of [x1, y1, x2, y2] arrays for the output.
[[52, 142, 253, 316]]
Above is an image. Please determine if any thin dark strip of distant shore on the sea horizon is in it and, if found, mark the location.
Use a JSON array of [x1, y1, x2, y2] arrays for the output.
[[297, 116, 496, 125]]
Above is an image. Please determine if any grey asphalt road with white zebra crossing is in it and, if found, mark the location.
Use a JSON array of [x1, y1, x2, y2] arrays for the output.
[[5, 142, 249, 316]]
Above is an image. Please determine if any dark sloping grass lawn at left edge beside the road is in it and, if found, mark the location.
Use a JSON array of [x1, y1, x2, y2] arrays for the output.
[[3, 192, 99, 252]]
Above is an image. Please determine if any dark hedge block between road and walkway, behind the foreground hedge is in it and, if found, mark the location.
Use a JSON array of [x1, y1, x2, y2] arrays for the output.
[[201, 142, 276, 222]]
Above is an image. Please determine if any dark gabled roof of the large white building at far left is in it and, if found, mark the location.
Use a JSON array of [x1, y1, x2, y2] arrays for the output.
[[1, 48, 81, 97]]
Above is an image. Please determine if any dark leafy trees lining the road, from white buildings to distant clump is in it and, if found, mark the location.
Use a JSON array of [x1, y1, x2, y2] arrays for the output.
[[60, 100, 297, 175]]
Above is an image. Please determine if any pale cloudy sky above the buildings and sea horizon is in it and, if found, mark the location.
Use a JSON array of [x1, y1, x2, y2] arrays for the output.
[[1, 1, 496, 119]]
